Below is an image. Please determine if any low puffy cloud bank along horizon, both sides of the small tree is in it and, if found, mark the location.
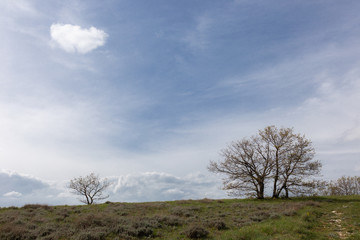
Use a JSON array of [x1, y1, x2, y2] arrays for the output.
[[0, 170, 226, 207]]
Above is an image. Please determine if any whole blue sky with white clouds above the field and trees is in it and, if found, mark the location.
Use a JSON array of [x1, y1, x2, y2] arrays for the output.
[[0, 0, 360, 206]]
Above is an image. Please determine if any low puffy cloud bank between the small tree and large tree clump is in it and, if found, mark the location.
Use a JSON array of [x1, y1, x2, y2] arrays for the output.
[[111, 172, 226, 201]]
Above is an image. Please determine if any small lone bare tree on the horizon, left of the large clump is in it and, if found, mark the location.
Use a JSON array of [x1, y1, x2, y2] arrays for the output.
[[68, 173, 110, 205]]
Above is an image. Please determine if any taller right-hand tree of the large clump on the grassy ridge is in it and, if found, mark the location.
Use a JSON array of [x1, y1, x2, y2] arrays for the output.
[[259, 126, 321, 198]]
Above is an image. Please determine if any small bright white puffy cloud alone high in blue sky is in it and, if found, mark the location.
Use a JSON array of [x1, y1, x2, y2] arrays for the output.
[[50, 24, 108, 54]]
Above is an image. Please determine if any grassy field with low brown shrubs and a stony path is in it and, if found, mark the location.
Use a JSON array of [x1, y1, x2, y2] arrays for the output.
[[0, 196, 360, 240]]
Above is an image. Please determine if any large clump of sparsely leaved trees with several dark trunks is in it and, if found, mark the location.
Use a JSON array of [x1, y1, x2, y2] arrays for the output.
[[209, 126, 321, 198]]
